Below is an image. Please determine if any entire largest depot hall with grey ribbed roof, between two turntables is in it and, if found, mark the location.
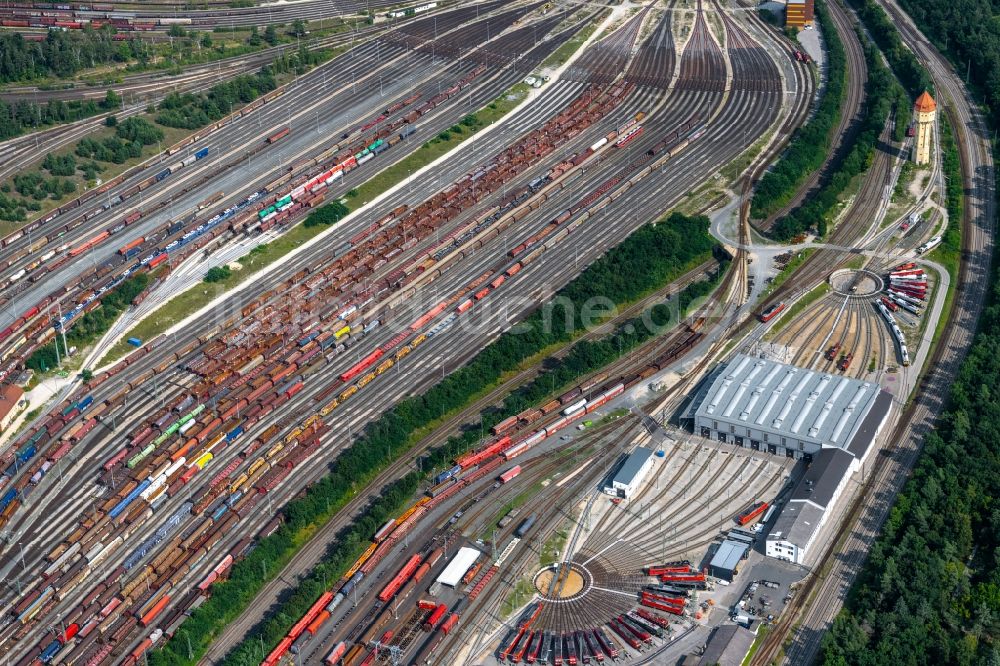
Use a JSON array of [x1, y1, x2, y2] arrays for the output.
[[681, 354, 892, 460]]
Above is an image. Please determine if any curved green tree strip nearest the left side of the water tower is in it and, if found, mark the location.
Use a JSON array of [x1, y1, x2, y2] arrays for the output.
[[772, 30, 901, 241]]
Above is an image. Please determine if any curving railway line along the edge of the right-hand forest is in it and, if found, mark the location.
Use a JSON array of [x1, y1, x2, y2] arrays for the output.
[[753, 1, 996, 664]]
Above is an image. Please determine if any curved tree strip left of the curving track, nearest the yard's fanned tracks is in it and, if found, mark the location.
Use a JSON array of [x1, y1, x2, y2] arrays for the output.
[[750, 2, 847, 219]]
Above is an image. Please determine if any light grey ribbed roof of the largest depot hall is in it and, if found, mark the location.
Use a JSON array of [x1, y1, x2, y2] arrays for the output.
[[694, 354, 883, 449]]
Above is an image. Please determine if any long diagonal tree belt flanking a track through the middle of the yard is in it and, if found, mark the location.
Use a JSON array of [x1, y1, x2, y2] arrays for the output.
[[149, 214, 721, 666]]
